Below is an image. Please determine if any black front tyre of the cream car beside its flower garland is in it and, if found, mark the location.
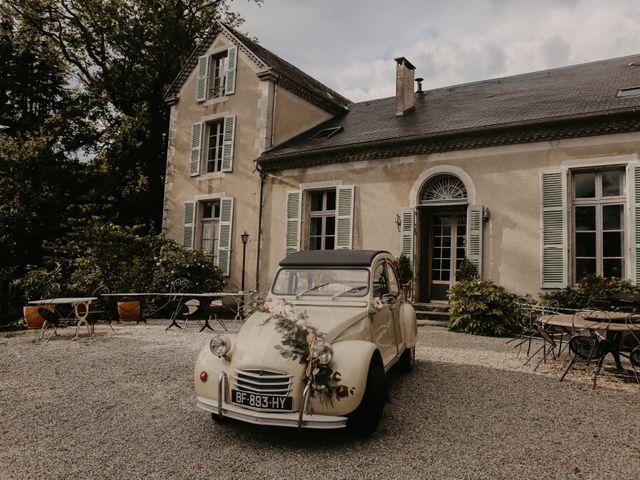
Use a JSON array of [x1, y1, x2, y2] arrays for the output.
[[347, 358, 387, 437]]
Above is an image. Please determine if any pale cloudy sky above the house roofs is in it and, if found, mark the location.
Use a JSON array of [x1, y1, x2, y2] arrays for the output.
[[232, 0, 640, 101]]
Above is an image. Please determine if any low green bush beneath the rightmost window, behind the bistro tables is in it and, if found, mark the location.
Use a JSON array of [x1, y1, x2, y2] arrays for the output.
[[540, 275, 640, 309]]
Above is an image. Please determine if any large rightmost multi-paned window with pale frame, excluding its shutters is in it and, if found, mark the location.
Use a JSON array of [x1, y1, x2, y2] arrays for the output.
[[572, 169, 626, 283]]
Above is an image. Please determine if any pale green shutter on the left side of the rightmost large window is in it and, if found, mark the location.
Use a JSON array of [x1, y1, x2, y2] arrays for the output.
[[540, 171, 568, 288]]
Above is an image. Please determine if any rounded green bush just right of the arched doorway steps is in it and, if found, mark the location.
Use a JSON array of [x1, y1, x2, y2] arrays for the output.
[[449, 278, 519, 336]]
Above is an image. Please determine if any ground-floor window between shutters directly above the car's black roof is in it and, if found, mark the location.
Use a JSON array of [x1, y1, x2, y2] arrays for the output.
[[309, 189, 336, 250]]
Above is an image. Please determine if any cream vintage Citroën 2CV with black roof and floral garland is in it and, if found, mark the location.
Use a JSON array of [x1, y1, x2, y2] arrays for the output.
[[194, 250, 417, 435]]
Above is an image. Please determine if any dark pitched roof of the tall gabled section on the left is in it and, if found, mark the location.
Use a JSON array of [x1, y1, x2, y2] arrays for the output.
[[165, 22, 352, 115]]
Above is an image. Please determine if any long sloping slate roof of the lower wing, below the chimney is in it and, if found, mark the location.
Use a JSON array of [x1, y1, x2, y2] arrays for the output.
[[258, 55, 640, 171]]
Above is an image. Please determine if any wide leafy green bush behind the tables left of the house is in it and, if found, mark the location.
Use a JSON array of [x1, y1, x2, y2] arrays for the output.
[[13, 218, 224, 300]]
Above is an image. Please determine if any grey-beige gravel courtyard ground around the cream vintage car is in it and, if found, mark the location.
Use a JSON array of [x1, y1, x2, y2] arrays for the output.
[[0, 321, 640, 480]]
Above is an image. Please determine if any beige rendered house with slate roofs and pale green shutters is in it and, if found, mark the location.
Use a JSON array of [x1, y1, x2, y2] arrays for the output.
[[163, 24, 640, 302]]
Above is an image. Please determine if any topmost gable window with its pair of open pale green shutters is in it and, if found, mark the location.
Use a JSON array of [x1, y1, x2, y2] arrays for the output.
[[196, 47, 238, 102]]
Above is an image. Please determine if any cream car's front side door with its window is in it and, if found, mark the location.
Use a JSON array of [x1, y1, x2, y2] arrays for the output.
[[371, 259, 398, 367]]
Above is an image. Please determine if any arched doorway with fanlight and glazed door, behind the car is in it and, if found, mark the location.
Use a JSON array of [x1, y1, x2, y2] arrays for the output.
[[417, 173, 468, 302]]
